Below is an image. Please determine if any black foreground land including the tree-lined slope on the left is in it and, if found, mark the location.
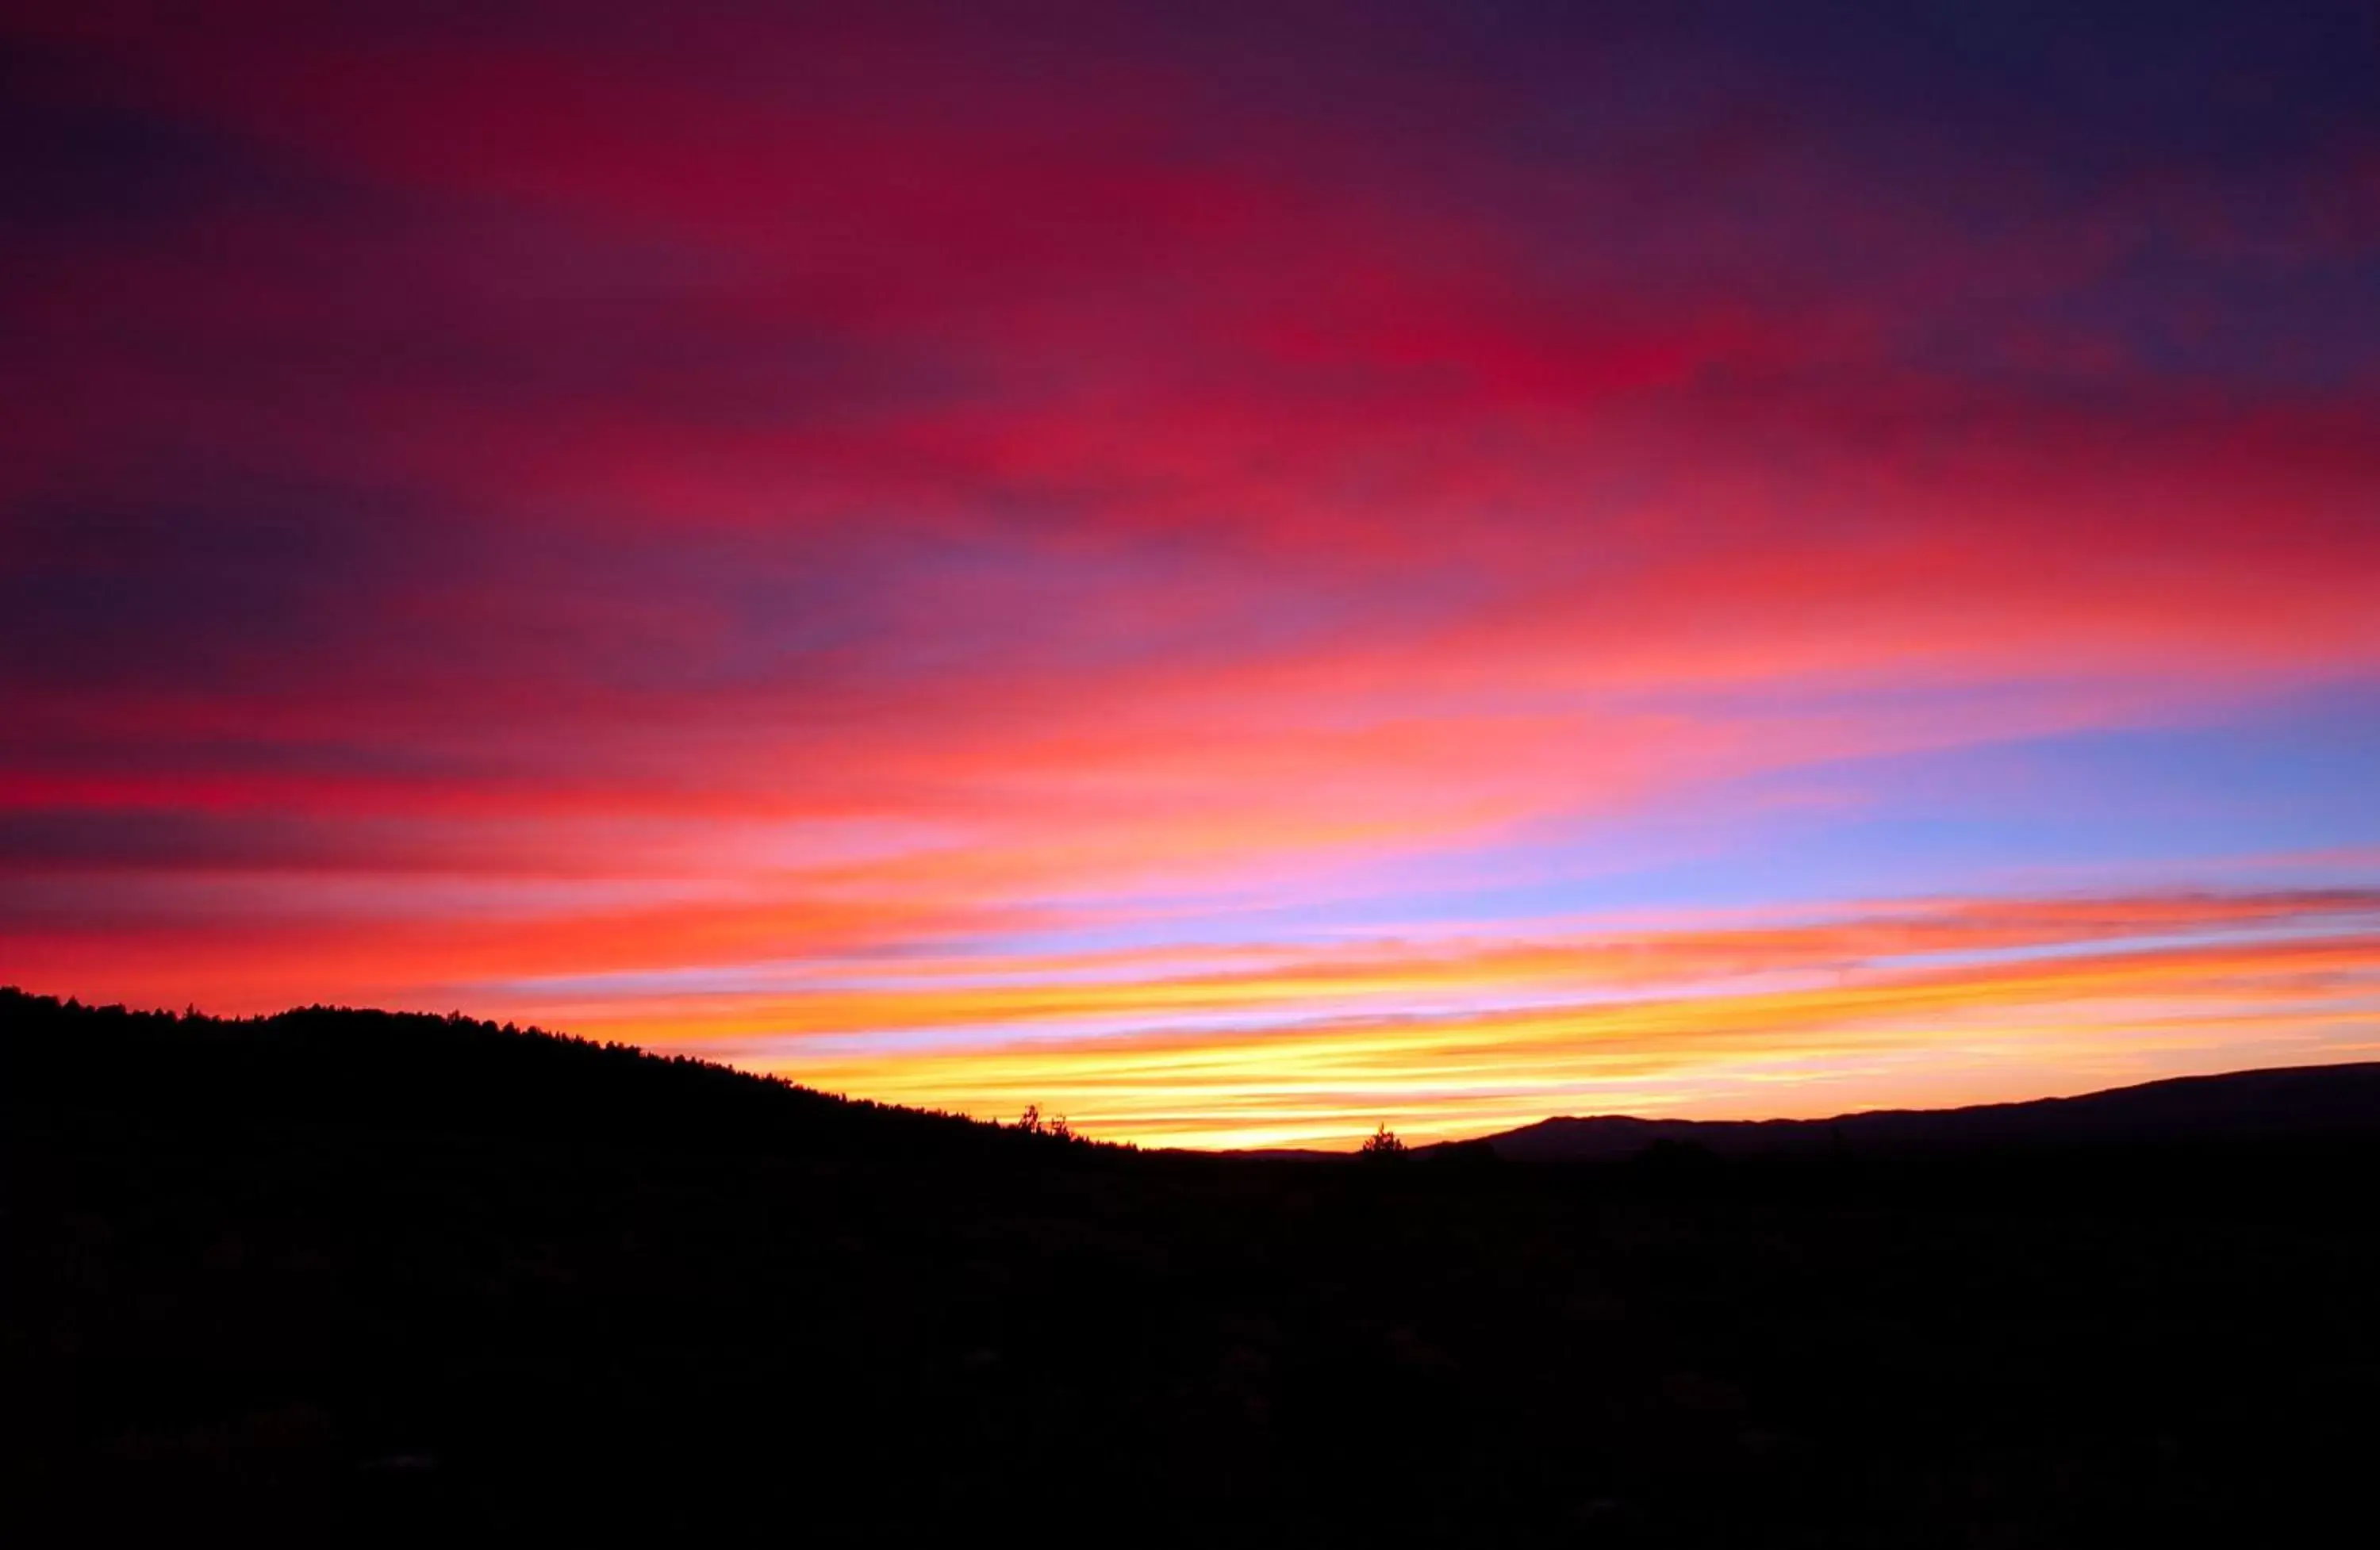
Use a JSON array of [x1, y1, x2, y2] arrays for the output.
[[0, 993, 2380, 1545]]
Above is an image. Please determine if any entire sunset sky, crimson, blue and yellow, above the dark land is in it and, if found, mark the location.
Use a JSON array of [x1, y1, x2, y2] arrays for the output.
[[0, 0, 2380, 1148]]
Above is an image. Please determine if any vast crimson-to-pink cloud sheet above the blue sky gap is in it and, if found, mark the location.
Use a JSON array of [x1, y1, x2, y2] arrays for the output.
[[0, 5, 2380, 1138]]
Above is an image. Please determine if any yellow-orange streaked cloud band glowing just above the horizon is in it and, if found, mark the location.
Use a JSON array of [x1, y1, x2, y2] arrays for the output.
[[497, 891, 2380, 1145]]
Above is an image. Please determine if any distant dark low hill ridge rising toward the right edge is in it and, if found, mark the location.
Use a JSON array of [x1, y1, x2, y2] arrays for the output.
[[1485, 1062, 2380, 1162]]
